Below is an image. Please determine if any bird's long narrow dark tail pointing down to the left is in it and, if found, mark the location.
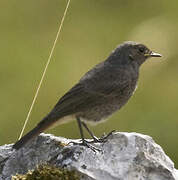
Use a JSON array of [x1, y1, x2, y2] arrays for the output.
[[13, 117, 56, 150]]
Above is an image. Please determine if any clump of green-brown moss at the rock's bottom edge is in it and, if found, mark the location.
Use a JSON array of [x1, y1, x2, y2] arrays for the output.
[[12, 164, 80, 180]]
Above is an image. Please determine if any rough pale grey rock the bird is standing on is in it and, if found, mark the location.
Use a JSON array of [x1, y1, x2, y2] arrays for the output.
[[0, 132, 178, 180]]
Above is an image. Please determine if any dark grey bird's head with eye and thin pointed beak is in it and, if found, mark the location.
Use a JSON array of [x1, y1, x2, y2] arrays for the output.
[[109, 41, 162, 66]]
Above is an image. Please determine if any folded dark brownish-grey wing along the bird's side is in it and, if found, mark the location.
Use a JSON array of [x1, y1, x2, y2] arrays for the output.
[[50, 77, 128, 116]]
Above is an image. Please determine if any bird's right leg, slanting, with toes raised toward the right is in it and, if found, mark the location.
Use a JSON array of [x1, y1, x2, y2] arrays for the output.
[[81, 121, 115, 143]]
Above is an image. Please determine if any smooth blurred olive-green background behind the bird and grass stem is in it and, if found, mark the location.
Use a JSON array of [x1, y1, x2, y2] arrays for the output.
[[0, 0, 178, 168]]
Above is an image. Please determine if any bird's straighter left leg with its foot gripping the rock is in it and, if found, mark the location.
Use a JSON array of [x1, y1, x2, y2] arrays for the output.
[[70, 117, 101, 152]]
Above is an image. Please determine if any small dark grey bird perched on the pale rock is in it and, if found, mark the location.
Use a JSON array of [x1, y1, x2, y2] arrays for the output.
[[13, 41, 162, 150]]
